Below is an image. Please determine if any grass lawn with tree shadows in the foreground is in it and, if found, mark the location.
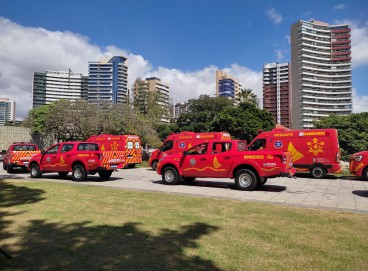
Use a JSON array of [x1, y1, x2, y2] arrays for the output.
[[0, 180, 368, 271]]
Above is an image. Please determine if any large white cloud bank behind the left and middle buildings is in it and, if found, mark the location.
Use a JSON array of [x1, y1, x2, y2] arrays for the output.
[[0, 17, 262, 119]]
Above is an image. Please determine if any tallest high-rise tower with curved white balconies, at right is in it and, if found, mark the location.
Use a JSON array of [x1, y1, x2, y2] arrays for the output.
[[291, 20, 352, 129]]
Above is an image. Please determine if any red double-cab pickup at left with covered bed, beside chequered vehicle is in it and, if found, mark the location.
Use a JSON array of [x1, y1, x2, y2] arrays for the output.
[[28, 142, 117, 181]]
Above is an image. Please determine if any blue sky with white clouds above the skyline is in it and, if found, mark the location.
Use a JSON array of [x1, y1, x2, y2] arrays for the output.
[[0, 0, 368, 120]]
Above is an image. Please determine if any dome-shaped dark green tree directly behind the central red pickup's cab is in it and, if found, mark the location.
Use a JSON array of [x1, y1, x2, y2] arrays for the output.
[[210, 103, 275, 143]]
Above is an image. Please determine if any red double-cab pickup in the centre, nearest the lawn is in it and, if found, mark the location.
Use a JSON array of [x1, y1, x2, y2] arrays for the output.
[[157, 140, 295, 191]]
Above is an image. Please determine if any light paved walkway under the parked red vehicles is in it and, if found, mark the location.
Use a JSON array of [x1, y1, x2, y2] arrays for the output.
[[0, 168, 368, 214]]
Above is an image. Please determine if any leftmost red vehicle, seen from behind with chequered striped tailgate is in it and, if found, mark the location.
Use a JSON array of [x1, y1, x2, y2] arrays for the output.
[[3, 142, 41, 173]]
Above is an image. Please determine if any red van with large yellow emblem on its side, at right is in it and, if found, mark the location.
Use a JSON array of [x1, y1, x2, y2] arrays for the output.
[[249, 128, 341, 178]]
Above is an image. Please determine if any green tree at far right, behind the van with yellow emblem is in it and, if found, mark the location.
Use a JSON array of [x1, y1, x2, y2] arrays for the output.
[[313, 112, 368, 161]]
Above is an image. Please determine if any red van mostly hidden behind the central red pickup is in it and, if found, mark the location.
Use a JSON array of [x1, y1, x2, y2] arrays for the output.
[[148, 131, 231, 170]]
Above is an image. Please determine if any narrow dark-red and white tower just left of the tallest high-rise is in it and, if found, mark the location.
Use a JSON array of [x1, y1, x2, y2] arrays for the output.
[[263, 62, 291, 128]]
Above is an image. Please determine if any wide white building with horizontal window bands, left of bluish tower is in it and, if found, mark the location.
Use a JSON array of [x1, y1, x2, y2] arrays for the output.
[[32, 70, 88, 108]]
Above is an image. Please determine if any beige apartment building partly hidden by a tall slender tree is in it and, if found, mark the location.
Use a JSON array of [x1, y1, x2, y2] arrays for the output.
[[133, 77, 170, 122]]
